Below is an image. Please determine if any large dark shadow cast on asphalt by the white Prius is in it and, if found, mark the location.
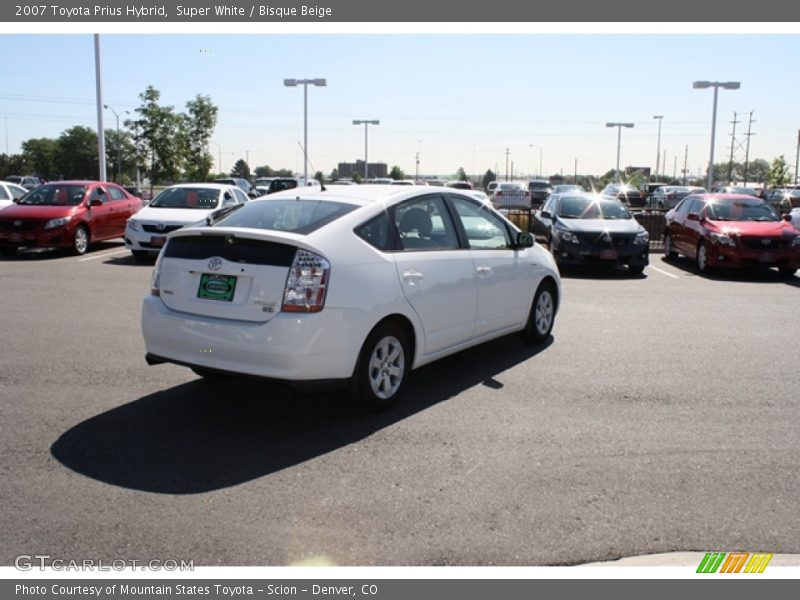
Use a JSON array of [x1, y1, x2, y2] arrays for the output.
[[51, 336, 553, 494]]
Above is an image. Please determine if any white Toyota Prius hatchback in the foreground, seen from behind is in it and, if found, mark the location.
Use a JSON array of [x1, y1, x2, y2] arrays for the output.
[[142, 185, 561, 409]]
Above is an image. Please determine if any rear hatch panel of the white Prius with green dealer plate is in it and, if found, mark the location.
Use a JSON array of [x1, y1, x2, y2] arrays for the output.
[[158, 228, 298, 323]]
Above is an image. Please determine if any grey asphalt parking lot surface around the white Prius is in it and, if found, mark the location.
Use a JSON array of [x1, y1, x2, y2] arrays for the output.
[[0, 242, 800, 565]]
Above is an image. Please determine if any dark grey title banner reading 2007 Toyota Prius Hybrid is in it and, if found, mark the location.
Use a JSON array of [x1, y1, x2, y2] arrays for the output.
[[0, 0, 800, 23]]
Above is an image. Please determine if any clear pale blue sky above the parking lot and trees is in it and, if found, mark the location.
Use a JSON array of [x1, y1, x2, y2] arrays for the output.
[[0, 24, 800, 179]]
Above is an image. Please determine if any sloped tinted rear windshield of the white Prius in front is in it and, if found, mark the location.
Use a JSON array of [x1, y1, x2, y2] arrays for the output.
[[214, 199, 357, 234]]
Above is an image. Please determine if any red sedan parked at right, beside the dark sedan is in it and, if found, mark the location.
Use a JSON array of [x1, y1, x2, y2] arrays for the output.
[[664, 194, 800, 277]]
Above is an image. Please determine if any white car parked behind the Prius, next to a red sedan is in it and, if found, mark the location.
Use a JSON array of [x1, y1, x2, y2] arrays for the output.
[[125, 183, 248, 260]]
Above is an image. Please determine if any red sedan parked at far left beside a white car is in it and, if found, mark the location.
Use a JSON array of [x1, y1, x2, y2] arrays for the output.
[[0, 181, 142, 254]]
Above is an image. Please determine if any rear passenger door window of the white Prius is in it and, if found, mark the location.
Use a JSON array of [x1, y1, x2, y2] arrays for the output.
[[394, 196, 459, 251]]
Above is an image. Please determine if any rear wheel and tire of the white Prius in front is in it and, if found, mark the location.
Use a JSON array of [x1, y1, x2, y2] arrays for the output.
[[353, 323, 411, 411]]
